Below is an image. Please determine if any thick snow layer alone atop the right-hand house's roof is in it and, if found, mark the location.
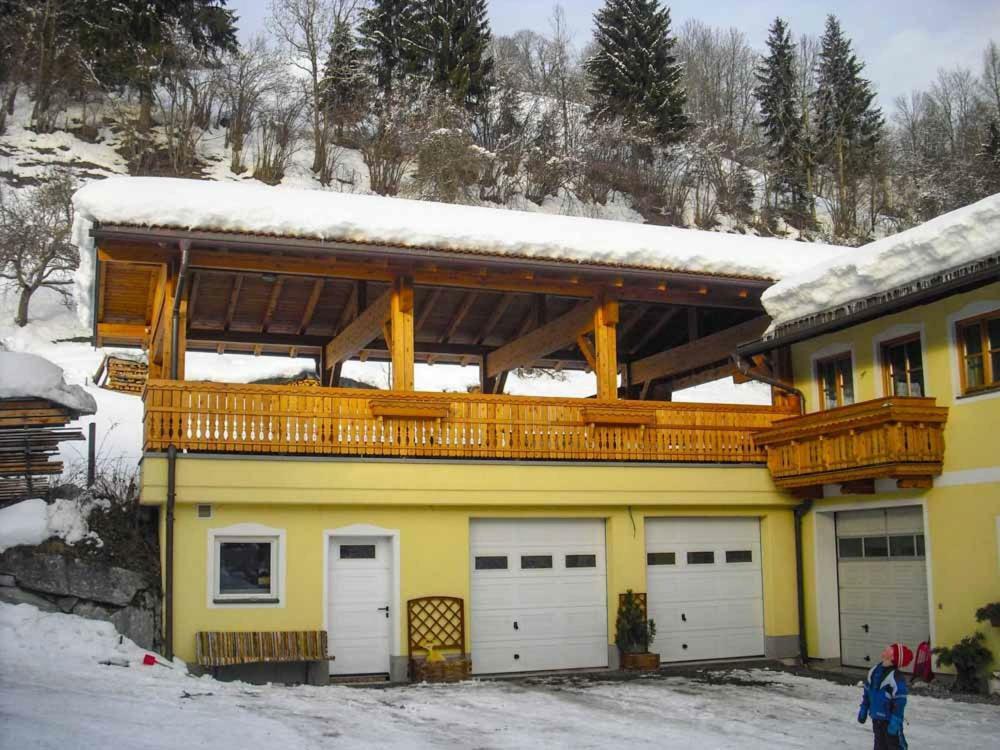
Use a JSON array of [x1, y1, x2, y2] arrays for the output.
[[761, 194, 1000, 329]]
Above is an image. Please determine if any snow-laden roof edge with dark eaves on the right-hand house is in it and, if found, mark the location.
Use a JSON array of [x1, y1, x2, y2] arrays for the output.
[[761, 193, 1000, 340]]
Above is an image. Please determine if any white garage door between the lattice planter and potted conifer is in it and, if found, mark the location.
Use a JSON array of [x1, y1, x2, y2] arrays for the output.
[[470, 519, 608, 674]]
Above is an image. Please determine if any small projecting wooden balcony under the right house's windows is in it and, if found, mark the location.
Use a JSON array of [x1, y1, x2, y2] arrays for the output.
[[754, 398, 948, 495]]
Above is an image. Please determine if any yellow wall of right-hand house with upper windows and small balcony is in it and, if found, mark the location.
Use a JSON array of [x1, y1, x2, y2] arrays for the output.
[[792, 283, 1000, 664]]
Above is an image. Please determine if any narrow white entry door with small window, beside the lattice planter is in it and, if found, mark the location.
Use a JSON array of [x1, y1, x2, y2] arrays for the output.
[[327, 537, 393, 675]]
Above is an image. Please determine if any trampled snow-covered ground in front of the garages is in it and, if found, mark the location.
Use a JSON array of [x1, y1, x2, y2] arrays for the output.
[[0, 604, 1000, 750]]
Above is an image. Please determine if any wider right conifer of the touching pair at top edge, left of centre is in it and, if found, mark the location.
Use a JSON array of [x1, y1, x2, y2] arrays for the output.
[[415, 0, 494, 112]]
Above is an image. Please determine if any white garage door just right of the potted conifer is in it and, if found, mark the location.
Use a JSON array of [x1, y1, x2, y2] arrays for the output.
[[646, 518, 764, 661]]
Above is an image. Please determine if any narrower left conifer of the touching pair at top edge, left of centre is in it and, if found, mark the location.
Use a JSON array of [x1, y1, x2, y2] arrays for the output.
[[358, 0, 425, 98]]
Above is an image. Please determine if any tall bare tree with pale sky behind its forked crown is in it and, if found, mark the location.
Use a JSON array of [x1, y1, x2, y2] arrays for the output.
[[269, 0, 359, 184]]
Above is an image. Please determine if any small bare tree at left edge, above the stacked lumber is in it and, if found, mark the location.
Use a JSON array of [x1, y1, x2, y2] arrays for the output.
[[0, 174, 80, 326]]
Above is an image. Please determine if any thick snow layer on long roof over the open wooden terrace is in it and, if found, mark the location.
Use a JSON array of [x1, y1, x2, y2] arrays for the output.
[[74, 177, 844, 279]]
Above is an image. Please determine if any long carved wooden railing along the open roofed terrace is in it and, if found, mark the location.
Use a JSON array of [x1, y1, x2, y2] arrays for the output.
[[144, 380, 789, 463]]
